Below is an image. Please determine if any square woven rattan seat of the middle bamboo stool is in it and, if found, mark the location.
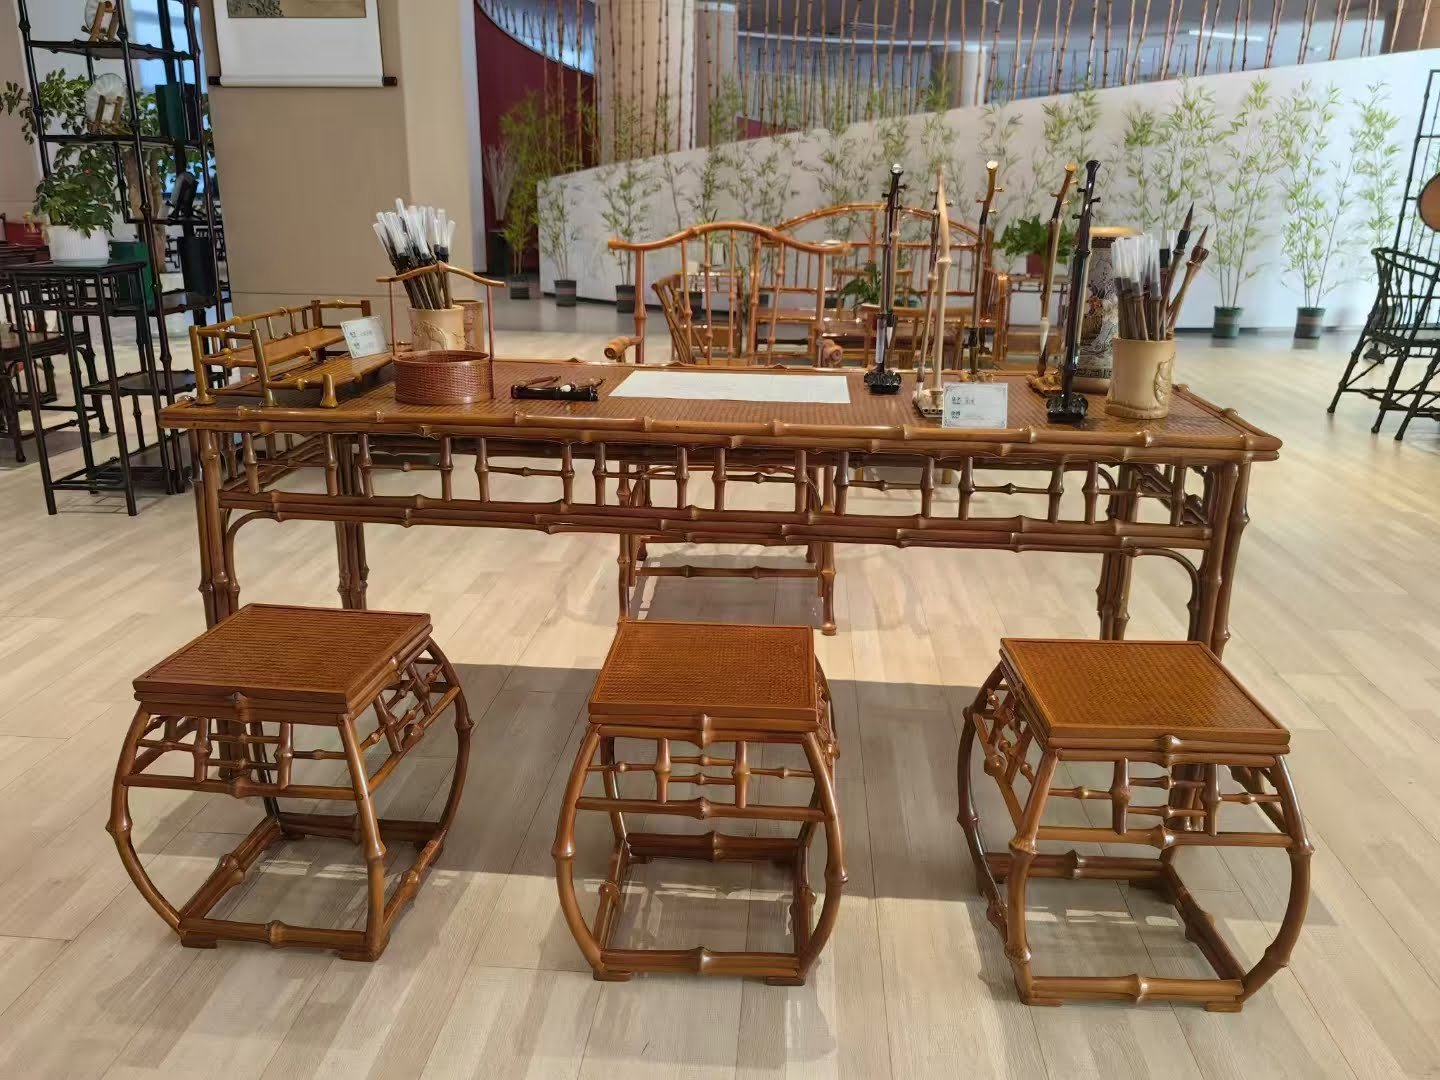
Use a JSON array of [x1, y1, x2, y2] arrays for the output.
[[590, 619, 819, 720]]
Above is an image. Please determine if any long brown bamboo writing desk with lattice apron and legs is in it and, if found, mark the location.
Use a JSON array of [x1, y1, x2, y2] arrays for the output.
[[163, 360, 1280, 652]]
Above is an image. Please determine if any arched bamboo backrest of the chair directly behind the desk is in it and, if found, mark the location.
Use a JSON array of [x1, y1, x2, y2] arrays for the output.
[[609, 222, 850, 363]]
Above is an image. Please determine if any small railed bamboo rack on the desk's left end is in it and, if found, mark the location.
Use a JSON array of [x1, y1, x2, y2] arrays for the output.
[[190, 300, 374, 408]]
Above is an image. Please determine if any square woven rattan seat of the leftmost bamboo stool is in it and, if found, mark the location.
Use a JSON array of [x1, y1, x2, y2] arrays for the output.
[[135, 603, 431, 707]]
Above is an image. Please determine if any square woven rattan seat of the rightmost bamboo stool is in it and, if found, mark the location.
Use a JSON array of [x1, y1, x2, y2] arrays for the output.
[[1001, 638, 1290, 747]]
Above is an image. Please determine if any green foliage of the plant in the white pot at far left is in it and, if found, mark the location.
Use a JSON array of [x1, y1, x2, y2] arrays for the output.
[[0, 71, 120, 236]]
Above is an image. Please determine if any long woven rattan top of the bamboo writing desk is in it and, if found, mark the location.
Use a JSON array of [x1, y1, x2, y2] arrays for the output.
[[161, 360, 1280, 458]]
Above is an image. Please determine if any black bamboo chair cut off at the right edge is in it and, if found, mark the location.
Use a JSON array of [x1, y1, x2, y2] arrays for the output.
[[1329, 248, 1440, 439]]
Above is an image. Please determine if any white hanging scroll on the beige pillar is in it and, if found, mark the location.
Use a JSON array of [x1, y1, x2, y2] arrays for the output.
[[215, 0, 383, 86]]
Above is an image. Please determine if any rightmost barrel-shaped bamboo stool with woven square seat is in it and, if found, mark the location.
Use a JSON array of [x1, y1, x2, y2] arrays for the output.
[[959, 638, 1310, 1012]]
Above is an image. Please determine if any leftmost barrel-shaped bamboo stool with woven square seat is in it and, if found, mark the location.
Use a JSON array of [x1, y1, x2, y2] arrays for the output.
[[108, 605, 471, 960]]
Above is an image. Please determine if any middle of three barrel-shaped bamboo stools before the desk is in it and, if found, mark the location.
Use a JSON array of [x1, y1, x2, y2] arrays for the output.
[[552, 621, 845, 986]]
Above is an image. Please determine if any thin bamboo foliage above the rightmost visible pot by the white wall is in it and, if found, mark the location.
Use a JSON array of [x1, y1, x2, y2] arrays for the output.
[[1274, 81, 1355, 308]]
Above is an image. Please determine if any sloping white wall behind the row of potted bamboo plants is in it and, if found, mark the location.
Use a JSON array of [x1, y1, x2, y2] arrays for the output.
[[540, 50, 1440, 328]]
